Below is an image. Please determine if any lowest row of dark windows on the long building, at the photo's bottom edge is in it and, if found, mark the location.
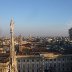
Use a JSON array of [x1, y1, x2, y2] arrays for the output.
[[18, 67, 72, 72]]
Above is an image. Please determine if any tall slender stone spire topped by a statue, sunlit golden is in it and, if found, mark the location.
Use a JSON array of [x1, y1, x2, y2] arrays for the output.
[[10, 18, 18, 72]]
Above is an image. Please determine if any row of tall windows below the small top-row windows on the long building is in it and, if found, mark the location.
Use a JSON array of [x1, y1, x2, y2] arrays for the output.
[[18, 63, 72, 68]]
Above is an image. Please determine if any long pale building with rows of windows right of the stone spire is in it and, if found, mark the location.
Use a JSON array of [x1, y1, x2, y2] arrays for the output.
[[17, 53, 72, 72]]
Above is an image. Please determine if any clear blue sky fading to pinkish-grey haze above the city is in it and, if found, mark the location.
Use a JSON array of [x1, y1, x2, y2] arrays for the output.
[[0, 0, 72, 36]]
